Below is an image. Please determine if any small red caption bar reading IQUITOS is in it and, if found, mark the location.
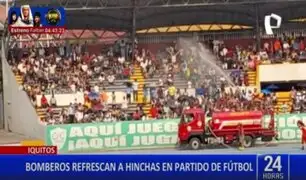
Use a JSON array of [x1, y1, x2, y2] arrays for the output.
[[0, 146, 57, 155]]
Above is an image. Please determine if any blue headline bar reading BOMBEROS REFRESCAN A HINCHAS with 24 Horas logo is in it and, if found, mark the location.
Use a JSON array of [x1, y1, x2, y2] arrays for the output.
[[0, 155, 306, 180]]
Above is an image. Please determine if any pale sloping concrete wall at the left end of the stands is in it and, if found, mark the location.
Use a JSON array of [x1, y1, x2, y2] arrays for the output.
[[1, 45, 45, 139]]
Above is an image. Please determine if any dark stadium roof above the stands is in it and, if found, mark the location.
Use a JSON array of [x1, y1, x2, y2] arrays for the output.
[[15, 0, 306, 31]]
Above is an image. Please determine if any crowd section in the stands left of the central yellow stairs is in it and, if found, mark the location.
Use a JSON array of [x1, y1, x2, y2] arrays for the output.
[[9, 41, 137, 122]]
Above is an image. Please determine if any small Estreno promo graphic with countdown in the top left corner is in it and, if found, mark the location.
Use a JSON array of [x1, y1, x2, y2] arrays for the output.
[[8, 5, 66, 35]]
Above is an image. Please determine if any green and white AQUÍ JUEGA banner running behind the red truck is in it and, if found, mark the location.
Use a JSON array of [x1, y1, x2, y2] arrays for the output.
[[45, 114, 306, 152]]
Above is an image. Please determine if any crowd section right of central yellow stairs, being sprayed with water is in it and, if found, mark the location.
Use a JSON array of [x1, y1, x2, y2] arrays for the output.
[[141, 34, 306, 121]]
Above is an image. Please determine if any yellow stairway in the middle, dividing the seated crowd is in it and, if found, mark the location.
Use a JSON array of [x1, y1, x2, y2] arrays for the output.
[[130, 66, 145, 104]]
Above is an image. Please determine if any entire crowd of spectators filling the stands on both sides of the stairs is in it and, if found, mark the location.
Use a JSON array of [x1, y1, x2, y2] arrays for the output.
[[9, 35, 306, 124]]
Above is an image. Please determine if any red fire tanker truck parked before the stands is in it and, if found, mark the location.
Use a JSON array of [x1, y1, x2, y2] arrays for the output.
[[178, 108, 277, 150]]
